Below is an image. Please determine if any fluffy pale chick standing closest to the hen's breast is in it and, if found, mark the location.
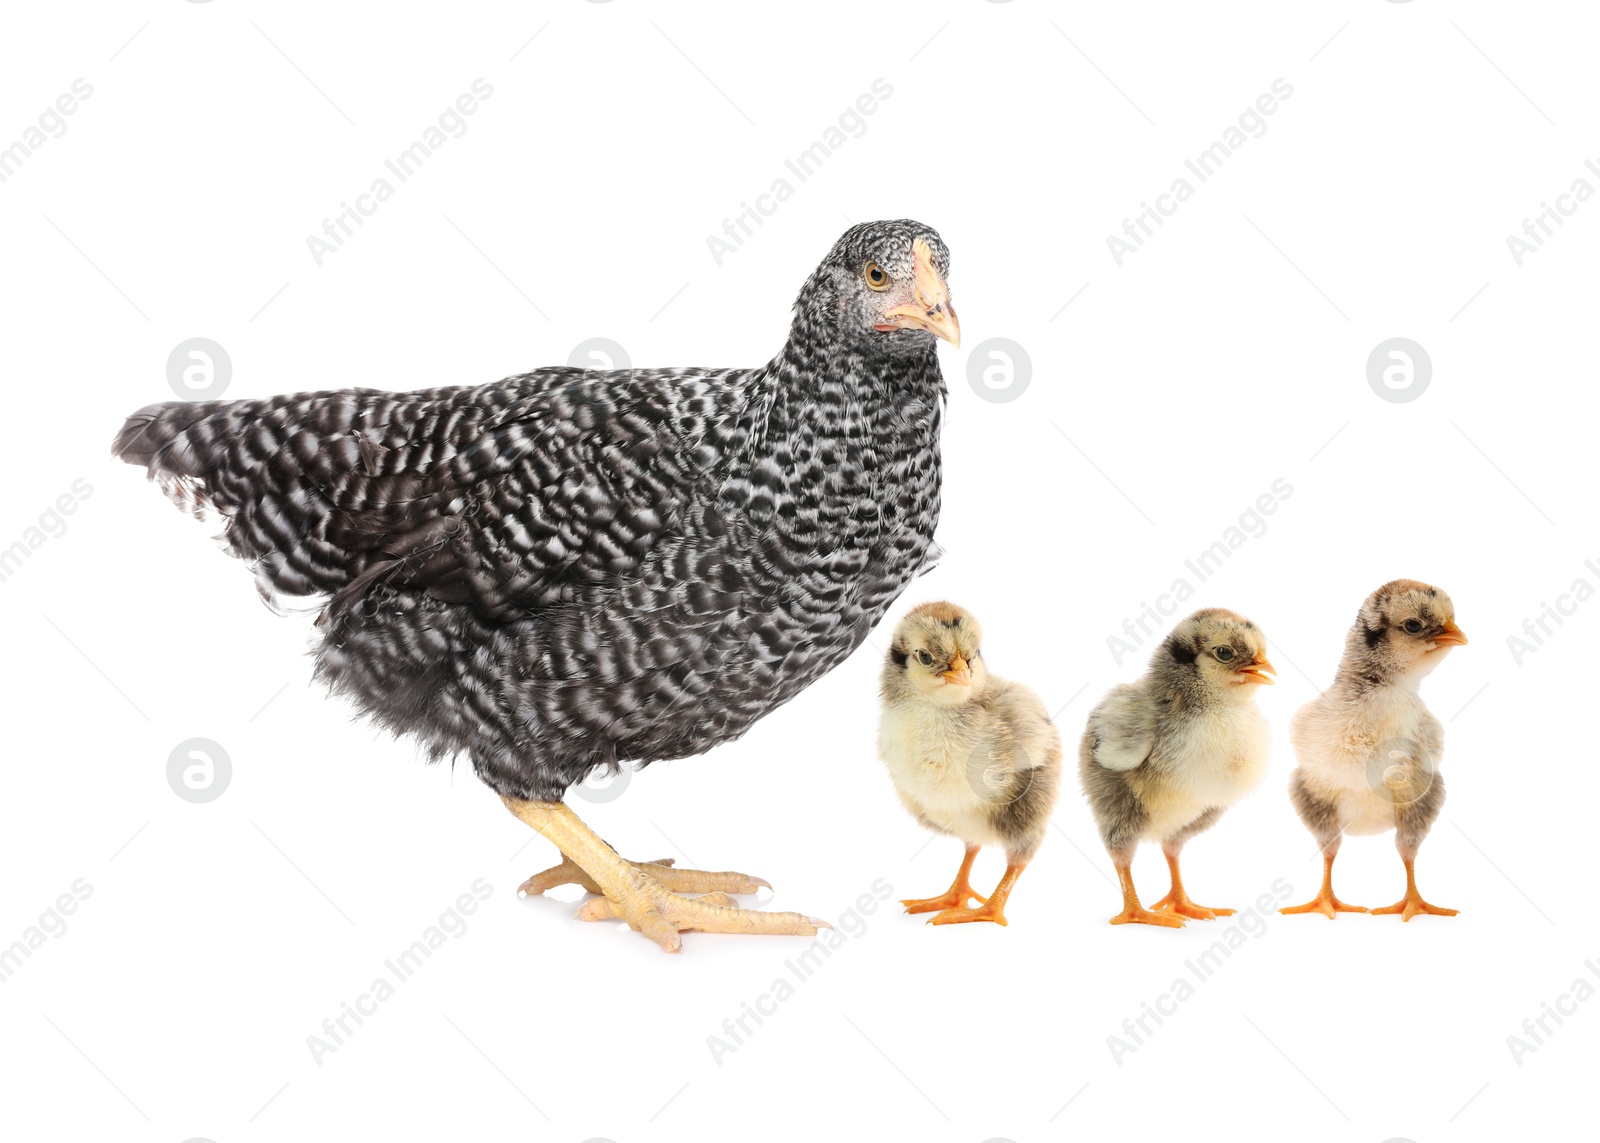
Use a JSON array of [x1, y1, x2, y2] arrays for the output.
[[878, 602, 1061, 925]]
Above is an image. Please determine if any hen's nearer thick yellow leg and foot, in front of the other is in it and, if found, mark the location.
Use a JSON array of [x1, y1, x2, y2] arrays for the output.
[[502, 797, 827, 953]]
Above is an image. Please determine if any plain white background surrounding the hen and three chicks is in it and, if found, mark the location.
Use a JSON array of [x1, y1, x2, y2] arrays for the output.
[[0, 0, 1600, 1143]]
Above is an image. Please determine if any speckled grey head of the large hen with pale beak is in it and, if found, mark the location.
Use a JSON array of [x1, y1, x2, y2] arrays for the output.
[[795, 219, 962, 354]]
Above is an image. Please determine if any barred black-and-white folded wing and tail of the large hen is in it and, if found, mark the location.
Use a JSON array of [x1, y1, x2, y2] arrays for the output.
[[114, 368, 746, 620]]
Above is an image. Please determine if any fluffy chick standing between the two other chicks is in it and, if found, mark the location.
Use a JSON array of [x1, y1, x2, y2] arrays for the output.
[[1078, 607, 1275, 928]]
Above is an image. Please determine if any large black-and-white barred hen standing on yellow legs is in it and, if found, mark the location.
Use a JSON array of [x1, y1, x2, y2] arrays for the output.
[[114, 221, 960, 951]]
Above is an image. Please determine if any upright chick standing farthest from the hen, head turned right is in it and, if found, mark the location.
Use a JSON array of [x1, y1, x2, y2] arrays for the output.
[[1283, 580, 1467, 920]]
